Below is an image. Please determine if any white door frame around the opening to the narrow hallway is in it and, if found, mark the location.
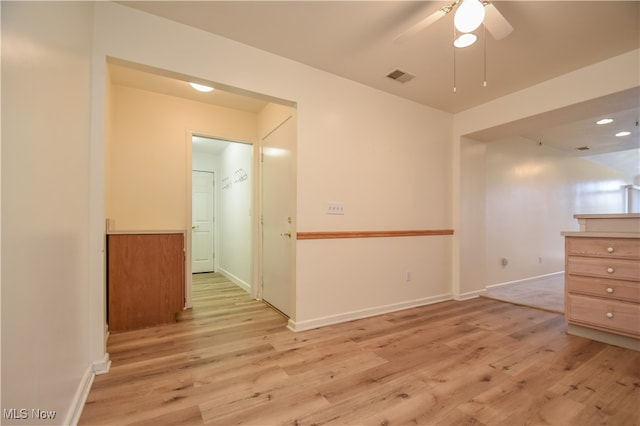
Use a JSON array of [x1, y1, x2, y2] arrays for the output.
[[184, 130, 261, 309]]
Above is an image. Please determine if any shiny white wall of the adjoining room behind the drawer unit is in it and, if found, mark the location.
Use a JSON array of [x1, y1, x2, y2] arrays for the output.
[[479, 137, 631, 285]]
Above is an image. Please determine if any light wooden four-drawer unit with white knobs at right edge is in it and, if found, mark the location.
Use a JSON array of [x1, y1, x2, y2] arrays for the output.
[[563, 214, 640, 350]]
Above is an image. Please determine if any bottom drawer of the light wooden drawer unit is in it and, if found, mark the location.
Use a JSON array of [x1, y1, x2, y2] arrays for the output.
[[565, 294, 640, 336]]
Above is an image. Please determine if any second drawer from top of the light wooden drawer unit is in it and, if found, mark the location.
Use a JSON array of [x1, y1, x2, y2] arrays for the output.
[[567, 256, 640, 281]]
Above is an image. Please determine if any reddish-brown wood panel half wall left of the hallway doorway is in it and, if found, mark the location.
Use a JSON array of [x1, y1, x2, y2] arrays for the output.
[[107, 232, 185, 332]]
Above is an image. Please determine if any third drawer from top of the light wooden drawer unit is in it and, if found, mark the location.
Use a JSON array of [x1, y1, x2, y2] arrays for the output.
[[565, 275, 640, 303]]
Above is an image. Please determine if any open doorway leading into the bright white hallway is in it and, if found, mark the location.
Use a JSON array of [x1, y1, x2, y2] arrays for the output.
[[186, 134, 255, 307]]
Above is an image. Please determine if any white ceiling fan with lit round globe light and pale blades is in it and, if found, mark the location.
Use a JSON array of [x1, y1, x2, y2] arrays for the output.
[[394, 0, 513, 47]]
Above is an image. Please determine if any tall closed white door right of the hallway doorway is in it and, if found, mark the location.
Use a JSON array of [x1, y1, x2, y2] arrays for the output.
[[262, 117, 295, 316]]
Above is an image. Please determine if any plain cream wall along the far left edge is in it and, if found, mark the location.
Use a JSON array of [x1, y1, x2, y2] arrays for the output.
[[1, 2, 96, 424]]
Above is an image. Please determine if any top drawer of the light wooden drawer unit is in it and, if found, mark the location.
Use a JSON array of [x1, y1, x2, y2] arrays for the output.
[[566, 237, 640, 259]]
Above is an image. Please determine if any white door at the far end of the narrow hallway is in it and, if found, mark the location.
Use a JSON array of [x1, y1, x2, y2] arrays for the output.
[[191, 170, 215, 273]]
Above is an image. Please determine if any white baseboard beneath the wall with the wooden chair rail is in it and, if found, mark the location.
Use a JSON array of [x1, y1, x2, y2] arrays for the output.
[[287, 293, 452, 332]]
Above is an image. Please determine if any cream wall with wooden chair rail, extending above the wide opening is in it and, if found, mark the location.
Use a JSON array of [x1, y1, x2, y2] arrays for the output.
[[96, 3, 452, 330]]
